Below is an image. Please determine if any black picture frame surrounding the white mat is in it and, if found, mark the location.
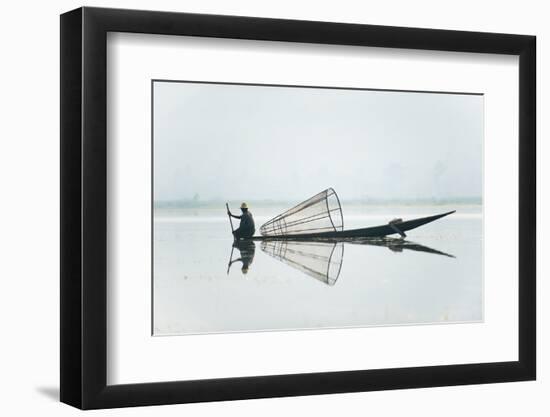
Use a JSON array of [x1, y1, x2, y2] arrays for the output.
[[60, 7, 536, 409]]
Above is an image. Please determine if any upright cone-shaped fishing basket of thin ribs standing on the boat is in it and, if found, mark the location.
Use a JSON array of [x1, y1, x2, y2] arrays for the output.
[[260, 188, 344, 236]]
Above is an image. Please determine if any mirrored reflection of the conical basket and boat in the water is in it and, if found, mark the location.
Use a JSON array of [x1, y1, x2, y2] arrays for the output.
[[258, 238, 454, 286]]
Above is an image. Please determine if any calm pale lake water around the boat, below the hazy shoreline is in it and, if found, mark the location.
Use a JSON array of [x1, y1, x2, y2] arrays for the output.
[[153, 205, 483, 335]]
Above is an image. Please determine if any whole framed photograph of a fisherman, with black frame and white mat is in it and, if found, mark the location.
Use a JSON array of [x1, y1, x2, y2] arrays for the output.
[[60, 7, 536, 409]]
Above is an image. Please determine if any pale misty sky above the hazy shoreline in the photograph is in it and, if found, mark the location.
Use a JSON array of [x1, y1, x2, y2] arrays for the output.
[[153, 81, 483, 201]]
